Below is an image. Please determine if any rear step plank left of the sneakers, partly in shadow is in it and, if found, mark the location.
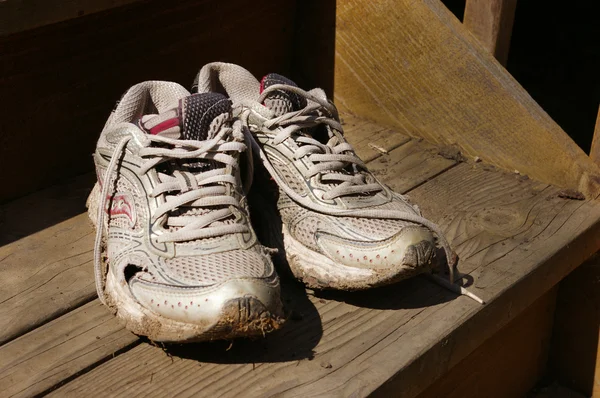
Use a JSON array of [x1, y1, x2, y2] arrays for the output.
[[0, 174, 95, 344]]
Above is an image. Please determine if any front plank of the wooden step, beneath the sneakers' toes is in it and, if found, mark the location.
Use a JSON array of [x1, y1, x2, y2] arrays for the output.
[[49, 151, 600, 397]]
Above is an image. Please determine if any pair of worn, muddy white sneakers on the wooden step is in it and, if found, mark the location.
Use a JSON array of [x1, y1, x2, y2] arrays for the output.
[[88, 63, 478, 342]]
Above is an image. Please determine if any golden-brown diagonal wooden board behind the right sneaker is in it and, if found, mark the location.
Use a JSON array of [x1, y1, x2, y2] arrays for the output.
[[328, 0, 600, 197]]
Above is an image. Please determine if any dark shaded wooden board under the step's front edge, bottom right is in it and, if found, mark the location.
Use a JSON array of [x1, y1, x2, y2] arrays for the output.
[[418, 287, 557, 398]]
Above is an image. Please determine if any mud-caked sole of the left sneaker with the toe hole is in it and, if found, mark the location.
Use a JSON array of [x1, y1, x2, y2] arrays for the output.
[[86, 184, 284, 343]]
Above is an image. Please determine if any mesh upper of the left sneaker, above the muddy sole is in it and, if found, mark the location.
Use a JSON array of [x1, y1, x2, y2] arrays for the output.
[[94, 82, 277, 313]]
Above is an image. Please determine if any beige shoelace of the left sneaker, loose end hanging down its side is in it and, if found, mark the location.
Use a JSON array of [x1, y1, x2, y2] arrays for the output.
[[94, 123, 248, 303]]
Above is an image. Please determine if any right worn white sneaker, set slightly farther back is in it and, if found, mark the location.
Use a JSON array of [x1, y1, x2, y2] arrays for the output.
[[193, 63, 457, 291]]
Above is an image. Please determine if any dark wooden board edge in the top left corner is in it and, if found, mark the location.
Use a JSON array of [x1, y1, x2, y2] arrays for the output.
[[0, 0, 144, 36]]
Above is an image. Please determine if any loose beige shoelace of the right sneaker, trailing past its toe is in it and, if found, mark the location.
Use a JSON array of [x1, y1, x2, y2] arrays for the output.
[[257, 84, 484, 304]]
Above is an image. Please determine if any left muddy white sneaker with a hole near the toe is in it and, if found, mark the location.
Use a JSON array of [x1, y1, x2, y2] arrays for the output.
[[88, 81, 283, 342]]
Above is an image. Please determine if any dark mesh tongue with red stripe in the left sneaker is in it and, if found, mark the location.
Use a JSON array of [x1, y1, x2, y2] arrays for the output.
[[140, 93, 231, 141]]
